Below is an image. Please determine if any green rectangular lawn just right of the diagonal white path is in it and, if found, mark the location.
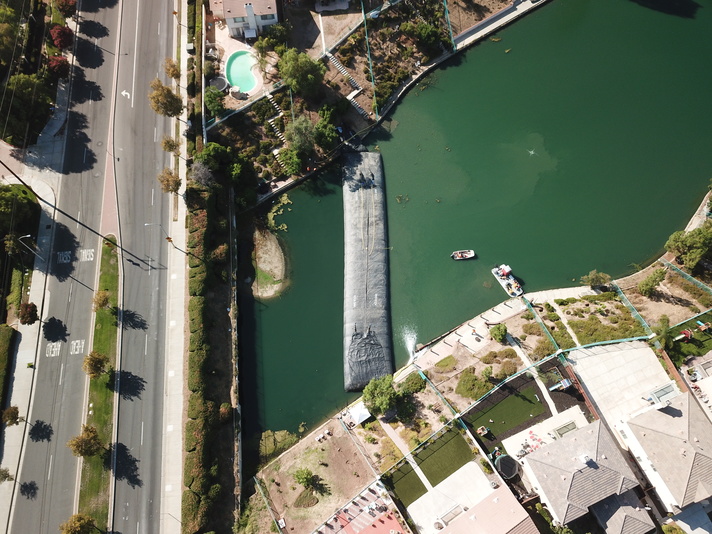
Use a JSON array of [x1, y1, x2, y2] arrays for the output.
[[415, 428, 475, 486]]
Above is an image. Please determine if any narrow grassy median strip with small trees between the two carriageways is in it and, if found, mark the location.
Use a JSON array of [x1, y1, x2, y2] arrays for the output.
[[79, 237, 119, 525]]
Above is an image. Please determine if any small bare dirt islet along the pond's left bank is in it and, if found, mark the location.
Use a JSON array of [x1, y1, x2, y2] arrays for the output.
[[252, 228, 287, 299]]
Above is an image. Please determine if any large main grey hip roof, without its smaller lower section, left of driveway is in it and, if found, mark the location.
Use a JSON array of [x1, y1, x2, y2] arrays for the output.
[[525, 421, 638, 524]]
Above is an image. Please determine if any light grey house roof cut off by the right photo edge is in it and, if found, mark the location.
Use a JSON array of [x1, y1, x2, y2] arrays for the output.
[[628, 393, 712, 508]]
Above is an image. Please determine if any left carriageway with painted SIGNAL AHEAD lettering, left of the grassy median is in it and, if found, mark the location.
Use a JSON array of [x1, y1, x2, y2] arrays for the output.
[[10, 0, 118, 534]]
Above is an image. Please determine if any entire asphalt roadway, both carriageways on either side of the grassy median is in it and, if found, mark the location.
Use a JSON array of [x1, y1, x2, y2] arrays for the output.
[[10, 0, 174, 534]]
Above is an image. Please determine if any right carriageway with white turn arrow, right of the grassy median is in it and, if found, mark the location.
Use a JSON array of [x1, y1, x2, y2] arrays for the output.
[[113, 0, 174, 534]]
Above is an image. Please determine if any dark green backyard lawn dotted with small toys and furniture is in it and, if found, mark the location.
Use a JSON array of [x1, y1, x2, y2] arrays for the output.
[[463, 386, 546, 444]]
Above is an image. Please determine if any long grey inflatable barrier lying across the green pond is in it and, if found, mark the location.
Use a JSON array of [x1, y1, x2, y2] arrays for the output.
[[343, 152, 393, 391]]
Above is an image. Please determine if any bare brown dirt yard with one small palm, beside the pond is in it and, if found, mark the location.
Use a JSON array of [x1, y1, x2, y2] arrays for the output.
[[258, 419, 373, 532]]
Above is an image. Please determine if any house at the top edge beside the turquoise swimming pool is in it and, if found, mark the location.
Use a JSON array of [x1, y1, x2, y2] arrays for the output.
[[210, 0, 279, 39]]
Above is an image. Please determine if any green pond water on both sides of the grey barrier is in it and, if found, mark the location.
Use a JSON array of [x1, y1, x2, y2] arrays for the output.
[[240, 0, 712, 448]]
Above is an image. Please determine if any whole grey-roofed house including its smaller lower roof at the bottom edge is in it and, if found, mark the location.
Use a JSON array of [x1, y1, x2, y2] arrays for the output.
[[523, 420, 655, 534]]
